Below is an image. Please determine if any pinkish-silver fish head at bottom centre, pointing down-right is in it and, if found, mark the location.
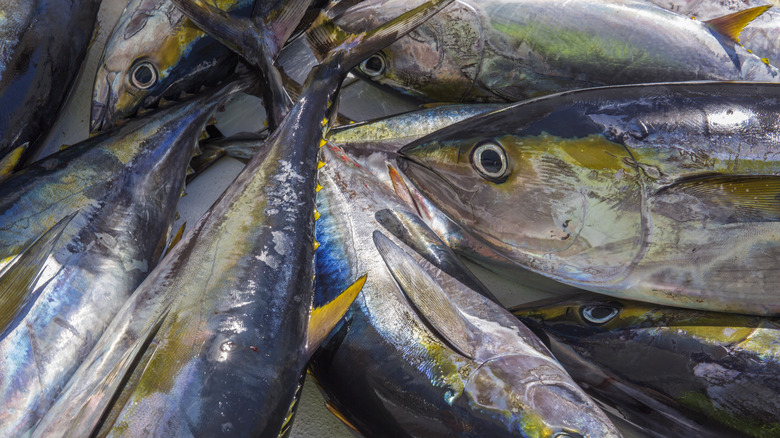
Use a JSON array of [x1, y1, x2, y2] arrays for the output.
[[465, 355, 620, 438]]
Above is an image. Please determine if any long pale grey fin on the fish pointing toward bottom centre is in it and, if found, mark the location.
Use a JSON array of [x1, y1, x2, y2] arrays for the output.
[[374, 231, 476, 359]]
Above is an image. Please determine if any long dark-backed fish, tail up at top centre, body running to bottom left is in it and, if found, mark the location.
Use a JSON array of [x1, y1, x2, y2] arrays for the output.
[[39, 0, 458, 437]]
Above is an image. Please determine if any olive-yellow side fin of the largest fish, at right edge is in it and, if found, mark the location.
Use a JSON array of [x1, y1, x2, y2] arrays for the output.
[[653, 175, 780, 223]]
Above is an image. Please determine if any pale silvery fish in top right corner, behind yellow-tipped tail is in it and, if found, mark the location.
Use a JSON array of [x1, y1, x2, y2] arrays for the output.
[[650, 0, 780, 70]]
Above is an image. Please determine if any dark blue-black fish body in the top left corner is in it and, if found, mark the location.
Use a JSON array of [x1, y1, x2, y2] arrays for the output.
[[0, 0, 100, 163]]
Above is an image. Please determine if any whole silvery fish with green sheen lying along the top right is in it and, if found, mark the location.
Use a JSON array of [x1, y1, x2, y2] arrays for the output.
[[318, 0, 780, 102]]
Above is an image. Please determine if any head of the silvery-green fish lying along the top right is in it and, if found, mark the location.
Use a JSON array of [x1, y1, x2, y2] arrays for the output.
[[328, 0, 483, 102]]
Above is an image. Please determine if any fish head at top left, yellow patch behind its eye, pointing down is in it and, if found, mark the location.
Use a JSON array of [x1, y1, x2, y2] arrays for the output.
[[90, 0, 254, 132]]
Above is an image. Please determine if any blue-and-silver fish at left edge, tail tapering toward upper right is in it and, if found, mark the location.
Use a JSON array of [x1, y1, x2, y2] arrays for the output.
[[0, 81, 241, 436]]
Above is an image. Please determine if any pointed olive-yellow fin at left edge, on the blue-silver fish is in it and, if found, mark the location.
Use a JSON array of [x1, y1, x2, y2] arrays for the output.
[[0, 213, 77, 333]]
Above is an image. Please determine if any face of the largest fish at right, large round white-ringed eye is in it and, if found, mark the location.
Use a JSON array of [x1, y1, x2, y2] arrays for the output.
[[398, 128, 612, 254]]
